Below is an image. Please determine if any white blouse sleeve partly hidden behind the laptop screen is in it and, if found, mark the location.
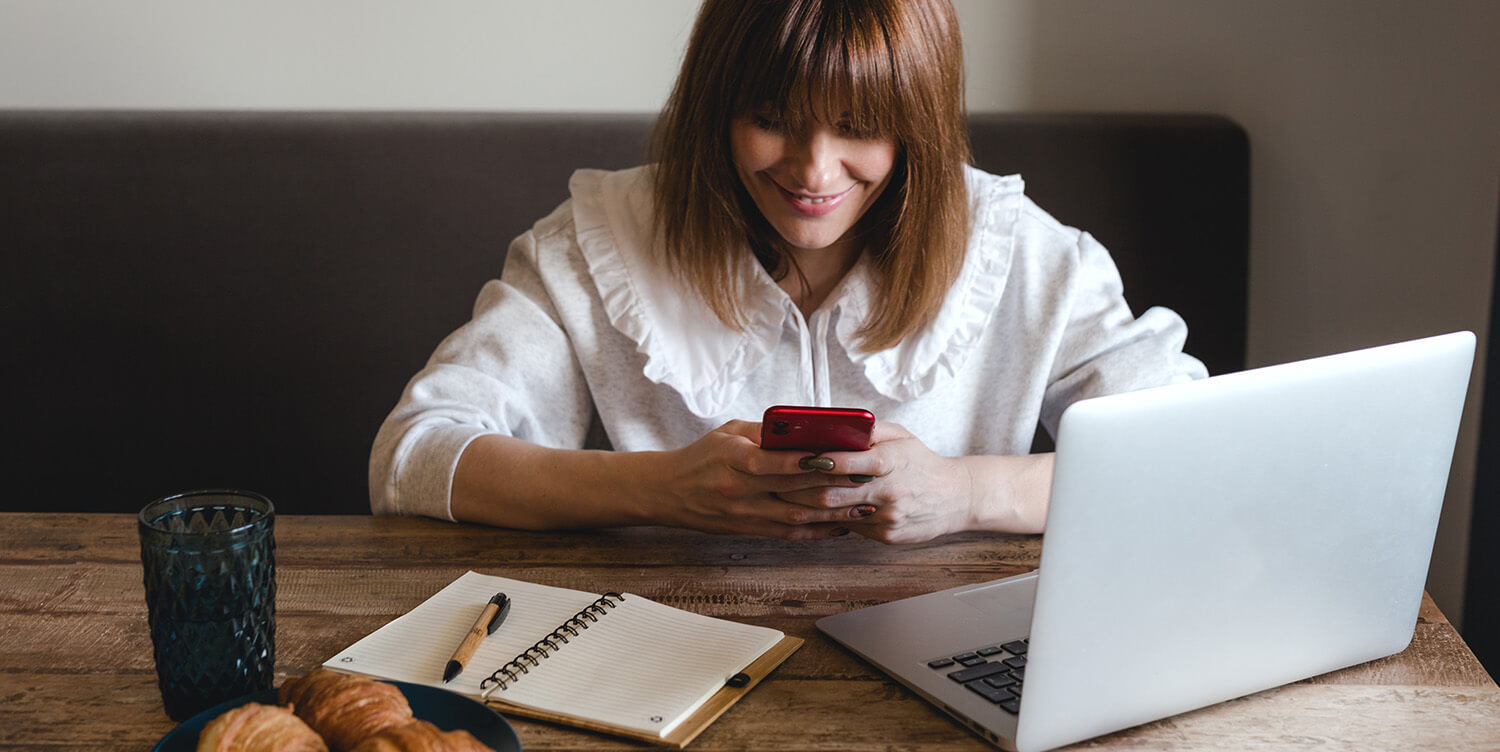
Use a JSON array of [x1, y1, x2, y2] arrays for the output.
[[1041, 233, 1208, 437]]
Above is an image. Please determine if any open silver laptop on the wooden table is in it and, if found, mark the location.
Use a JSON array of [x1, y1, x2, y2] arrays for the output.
[[818, 332, 1475, 752]]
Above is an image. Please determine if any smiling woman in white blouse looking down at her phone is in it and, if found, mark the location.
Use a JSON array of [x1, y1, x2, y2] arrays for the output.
[[371, 0, 1205, 542]]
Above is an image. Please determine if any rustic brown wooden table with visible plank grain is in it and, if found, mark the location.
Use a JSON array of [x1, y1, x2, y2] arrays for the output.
[[0, 513, 1500, 752]]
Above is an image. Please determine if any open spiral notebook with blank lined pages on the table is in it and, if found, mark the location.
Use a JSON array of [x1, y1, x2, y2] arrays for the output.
[[324, 572, 803, 747]]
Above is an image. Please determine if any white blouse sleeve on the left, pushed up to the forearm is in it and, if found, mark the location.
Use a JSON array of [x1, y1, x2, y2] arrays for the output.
[[369, 219, 593, 519]]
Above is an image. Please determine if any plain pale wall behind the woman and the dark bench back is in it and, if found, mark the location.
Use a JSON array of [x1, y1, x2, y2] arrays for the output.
[[0, 0, 1500, 620]]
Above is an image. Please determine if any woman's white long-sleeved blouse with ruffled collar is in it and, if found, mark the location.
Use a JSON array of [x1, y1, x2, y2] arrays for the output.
[[369, 168, 1206, 519]]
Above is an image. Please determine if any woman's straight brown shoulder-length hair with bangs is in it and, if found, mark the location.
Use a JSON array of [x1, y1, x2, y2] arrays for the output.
[[651, 0, 969, 351]]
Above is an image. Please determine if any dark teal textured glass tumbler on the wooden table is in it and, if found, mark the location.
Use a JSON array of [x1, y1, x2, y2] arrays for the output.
[[138, 491, 276, 720]]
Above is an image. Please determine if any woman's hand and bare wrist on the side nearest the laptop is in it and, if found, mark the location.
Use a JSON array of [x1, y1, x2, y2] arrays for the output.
[[780, 422, 1053, 543]]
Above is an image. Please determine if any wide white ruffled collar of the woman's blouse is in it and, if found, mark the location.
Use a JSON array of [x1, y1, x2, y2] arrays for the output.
[[569, 167, 1023, 417]]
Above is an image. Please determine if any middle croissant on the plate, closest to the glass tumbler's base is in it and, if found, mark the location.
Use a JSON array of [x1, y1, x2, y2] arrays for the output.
[[278, 668, 413, 752]]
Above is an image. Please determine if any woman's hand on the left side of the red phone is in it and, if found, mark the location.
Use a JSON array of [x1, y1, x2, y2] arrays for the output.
[[642, 420, 860, 540]]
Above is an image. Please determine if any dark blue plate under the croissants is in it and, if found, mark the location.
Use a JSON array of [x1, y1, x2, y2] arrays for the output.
[[152, 681, 521, 752]]
